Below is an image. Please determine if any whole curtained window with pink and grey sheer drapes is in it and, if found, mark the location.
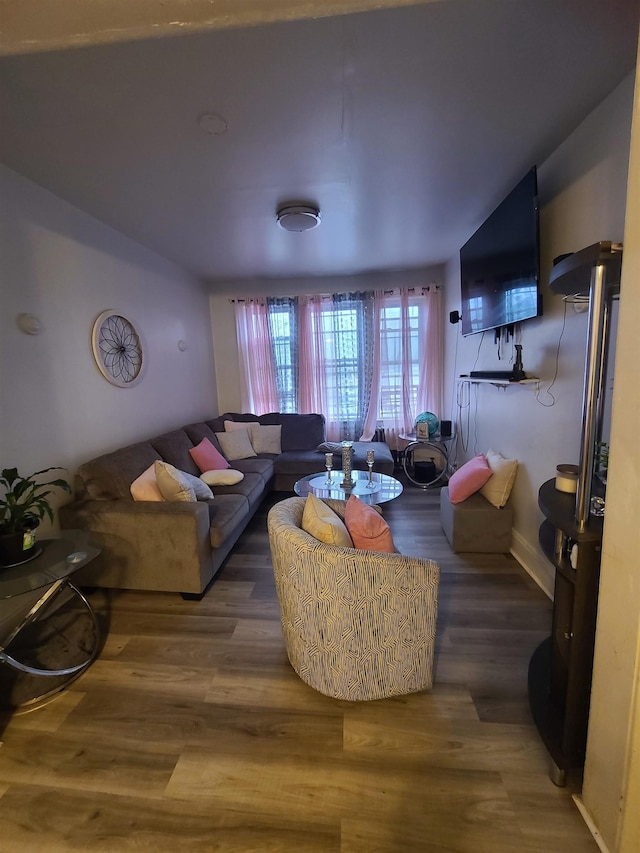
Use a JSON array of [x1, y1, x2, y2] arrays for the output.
[[236, 286, 442, 450]]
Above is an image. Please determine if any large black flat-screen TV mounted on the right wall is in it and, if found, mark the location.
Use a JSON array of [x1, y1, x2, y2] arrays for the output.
[[460, 166, 542, 335]]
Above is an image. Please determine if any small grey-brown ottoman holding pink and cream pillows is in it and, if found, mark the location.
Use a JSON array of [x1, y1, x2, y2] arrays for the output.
[[440, 486, 513, 554]]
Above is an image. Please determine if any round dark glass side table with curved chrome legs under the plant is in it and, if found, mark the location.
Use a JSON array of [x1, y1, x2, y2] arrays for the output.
[[0, 530, 100, 707]]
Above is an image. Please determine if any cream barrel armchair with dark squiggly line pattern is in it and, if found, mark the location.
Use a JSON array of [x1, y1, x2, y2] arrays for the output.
[[267, 497, 440, 701]]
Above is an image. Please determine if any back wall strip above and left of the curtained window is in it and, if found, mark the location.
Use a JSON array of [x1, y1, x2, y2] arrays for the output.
[[211, 266, 444, 412]]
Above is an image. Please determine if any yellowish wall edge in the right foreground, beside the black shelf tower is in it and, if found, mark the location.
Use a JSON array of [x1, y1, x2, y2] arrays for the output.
[[582, 55, 640, 853]]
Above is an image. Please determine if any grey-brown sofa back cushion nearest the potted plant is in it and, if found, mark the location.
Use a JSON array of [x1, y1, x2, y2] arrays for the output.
[[78, 441, 160, 501]]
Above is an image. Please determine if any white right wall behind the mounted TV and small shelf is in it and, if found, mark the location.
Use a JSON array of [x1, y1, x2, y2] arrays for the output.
[[445, 74, 634, 594]]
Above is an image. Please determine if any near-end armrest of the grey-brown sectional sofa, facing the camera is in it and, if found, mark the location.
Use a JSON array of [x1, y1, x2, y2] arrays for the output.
[[59, 500, 213, 594]]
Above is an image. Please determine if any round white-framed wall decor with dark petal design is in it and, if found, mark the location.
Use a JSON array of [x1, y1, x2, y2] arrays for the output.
[[91, 311, 144, 388]]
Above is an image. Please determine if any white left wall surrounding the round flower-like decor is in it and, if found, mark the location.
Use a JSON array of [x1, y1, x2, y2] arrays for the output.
[[0, 161, 217, 524]]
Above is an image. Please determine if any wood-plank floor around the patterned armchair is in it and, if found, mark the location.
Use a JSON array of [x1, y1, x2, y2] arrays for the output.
[[0, 487, 598, 853]]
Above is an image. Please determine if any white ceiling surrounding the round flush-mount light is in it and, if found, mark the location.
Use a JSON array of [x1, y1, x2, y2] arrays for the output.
[[0, 0, 639, 280]]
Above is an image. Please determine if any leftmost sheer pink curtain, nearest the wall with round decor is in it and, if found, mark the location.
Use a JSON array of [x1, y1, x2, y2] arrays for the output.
[[235, 299, 279, 415]]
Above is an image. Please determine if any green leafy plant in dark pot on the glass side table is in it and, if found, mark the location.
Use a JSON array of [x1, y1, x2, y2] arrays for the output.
[[0, 468, 71, 566]]
